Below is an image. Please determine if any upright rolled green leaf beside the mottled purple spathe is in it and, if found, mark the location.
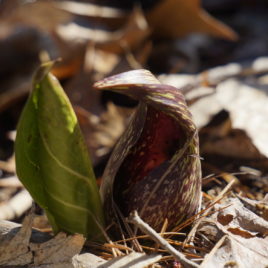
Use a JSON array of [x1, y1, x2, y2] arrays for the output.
[[15, 62, 104, 240]]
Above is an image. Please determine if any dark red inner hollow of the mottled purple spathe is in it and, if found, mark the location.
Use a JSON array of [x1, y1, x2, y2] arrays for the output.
[[115, 107, 185, 187]]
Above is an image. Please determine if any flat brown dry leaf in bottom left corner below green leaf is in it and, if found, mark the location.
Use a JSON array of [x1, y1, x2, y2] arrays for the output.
[[0, 214, 85, 268]]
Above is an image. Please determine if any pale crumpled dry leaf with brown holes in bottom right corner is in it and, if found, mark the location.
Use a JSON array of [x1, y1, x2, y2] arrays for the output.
[[198, 198, 268, 268]]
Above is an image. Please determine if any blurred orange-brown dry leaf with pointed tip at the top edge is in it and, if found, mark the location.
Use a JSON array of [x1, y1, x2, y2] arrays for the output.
[[146, 0, 237, 40]]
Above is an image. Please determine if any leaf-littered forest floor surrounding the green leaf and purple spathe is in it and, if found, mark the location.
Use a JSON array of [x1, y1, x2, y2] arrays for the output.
[[0, 0, 268, 268]]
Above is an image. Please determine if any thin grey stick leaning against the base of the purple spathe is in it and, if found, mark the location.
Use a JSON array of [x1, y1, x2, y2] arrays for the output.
[[128, 211, 199, 268]]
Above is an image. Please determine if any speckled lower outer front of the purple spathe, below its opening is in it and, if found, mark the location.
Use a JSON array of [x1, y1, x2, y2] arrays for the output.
[[114, 132, 201, 230]]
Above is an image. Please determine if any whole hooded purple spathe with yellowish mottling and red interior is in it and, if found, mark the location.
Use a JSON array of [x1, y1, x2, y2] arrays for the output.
[[95, 70, 201, 234]]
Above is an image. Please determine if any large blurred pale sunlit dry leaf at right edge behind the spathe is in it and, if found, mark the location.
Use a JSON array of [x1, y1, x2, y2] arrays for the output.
[[216, 79, 268, 157]]
